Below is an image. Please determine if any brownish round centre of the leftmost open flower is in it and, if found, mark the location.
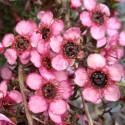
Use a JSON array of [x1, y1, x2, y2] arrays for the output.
[[16, 36, 29, 51]]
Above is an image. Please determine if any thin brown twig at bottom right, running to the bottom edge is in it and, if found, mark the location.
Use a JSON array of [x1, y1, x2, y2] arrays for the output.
[[79, 88, 94, 125]]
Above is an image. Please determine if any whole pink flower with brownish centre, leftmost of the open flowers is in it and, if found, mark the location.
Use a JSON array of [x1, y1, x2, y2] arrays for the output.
[[2, 20, 37, 65]]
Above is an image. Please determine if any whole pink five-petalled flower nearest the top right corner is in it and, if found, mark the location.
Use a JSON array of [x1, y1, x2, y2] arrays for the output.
[[80, 0, 121, 40]]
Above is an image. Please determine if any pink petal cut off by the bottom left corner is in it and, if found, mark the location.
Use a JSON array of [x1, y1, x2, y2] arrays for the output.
[[0, 113, 15, 125]]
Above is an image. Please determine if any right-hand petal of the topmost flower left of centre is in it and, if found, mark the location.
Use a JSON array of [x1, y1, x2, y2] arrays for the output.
[[51, 20, 64, 35]]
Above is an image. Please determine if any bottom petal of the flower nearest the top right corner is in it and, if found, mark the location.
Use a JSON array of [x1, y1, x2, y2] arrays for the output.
[[90, 26, 106, 40]]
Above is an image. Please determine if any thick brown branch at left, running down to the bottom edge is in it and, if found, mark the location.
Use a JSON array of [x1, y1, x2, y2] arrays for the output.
[[18, 64, 33, 125]]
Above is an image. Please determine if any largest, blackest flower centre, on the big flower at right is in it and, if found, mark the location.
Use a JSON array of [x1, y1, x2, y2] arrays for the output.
[[90, 71, 108, 88]]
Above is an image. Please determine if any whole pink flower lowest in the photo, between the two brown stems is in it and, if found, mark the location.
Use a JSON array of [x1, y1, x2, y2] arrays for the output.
[[26, 73, 72, 123]]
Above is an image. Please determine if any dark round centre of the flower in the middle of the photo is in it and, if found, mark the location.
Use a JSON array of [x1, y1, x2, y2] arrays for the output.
[[63, 42, 79, 58]]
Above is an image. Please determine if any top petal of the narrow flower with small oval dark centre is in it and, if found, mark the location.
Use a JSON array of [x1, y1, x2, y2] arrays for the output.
[[40, 11, 53, 25]]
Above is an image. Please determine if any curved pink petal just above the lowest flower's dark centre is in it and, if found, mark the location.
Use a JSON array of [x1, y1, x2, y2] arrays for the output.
[[39, 67, 56, 80]]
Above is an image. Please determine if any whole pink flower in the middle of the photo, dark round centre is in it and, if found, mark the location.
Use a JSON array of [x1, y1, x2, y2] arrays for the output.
[[50, 27, 84, 71]]
